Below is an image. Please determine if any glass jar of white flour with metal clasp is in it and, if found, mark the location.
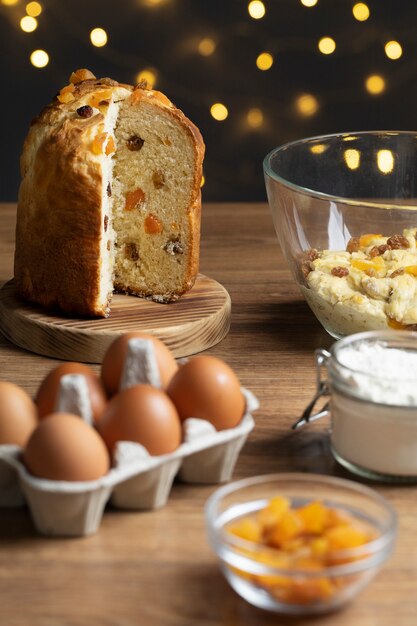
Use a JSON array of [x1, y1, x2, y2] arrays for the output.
[[293, 331, 417, 482]]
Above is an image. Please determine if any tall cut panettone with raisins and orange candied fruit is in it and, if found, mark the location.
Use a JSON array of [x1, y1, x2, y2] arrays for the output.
[[15, 70, 204, 316]]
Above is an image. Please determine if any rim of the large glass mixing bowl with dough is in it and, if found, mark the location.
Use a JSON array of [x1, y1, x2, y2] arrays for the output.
[[263, 130, 417, 211]]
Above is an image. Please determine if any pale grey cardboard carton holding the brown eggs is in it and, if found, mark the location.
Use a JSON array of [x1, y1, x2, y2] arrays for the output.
[[0, 388, 259, 536]]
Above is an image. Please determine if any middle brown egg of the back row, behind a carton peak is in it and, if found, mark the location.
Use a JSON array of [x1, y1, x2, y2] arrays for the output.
[[35, 362, 107, 423]]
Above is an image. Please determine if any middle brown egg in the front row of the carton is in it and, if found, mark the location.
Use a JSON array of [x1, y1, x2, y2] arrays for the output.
[[98, 385, 181, 456]]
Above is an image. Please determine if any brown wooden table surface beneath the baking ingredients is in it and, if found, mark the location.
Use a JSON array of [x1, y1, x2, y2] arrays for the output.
[[0, 204, 417, 626]]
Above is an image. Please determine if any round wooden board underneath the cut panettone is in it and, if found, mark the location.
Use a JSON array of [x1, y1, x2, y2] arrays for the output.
[[0, 274, 231, 363]]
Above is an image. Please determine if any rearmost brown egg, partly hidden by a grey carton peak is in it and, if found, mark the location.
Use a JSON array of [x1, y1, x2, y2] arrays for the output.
[[101, 332, 178, 395]]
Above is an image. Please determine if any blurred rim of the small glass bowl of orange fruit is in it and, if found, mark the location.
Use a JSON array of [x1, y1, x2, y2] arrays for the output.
[[204, 472, 397, 578]]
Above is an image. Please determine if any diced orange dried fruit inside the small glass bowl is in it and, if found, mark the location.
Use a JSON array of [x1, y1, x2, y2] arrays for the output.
[[227, 496, 375, 605]]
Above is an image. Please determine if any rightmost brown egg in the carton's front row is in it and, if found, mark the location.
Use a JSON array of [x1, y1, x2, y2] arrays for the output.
[[167, 355, 245, 430]]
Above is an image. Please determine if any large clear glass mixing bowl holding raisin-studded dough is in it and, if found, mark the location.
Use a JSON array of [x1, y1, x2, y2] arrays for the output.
[[264, 131, 417, 338]]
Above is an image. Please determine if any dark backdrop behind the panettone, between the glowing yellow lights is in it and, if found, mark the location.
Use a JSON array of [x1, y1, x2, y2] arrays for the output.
[[0, 0, 417, 201]]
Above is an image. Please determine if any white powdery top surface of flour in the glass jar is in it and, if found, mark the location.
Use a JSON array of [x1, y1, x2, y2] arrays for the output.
[[336, 341, 417, 406]]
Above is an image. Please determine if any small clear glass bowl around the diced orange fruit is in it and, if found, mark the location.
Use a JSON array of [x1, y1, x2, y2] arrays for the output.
[[205, 473, 396, 615]]
